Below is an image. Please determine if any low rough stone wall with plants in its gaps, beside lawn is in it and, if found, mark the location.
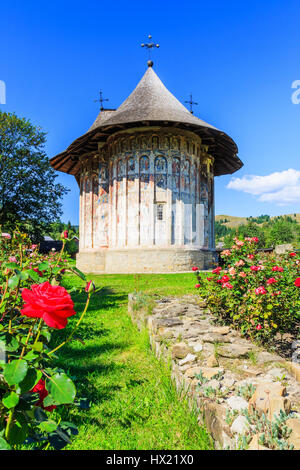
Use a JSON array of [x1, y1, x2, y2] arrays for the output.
[[128, 294, 300, 450]]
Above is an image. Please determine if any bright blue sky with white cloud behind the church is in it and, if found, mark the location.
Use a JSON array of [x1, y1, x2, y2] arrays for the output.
[[0, 0, 300, 224]]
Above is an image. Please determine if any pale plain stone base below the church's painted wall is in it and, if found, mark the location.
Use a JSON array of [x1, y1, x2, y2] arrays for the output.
[[76, 247, 215, 274]]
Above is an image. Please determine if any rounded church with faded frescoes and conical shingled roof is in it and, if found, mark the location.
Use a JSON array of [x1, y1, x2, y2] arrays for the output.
[[50, 61, 243, 274]]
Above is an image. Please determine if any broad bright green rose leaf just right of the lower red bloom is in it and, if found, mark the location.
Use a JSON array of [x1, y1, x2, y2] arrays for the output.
[[44, 373, 76, 406]]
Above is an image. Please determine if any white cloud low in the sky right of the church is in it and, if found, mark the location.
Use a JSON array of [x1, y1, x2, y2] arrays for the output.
[[227, 168, 300, 206]]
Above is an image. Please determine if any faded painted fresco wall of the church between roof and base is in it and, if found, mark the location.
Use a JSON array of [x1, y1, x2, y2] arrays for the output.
[[80, 129, 214, 250]]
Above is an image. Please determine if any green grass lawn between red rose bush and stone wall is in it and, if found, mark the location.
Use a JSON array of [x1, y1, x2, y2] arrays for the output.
[[50, 274, 212, 450]]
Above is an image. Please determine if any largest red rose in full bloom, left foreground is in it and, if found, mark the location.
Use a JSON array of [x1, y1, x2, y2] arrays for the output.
[[21, 281, 76, 329]]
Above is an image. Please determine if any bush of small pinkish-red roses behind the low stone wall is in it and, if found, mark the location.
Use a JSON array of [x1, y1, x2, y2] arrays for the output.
[[193, 237, 300, 342]]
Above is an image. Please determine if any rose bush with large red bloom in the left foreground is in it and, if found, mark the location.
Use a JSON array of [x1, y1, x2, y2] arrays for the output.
[[0, 230, 95, 449]]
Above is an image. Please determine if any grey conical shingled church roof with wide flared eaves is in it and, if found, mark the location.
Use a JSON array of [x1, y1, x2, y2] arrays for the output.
[[50, 67, 243, 176]]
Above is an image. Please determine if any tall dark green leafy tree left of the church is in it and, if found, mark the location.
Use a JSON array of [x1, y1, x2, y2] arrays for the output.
[[0, 111, 68, 239]]
